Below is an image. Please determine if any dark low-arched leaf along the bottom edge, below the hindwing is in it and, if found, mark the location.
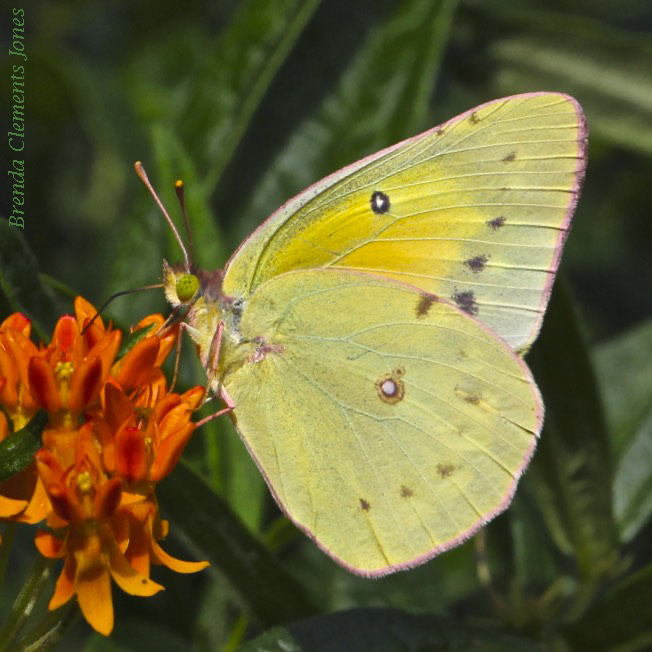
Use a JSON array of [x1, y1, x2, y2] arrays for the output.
[[238, 609, 542, 652]]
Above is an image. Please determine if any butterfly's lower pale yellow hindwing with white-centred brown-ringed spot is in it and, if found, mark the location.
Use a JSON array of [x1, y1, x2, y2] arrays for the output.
[[223, 269, 542, 575]]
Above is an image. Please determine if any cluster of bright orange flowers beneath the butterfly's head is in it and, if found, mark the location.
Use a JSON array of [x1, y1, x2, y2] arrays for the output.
[[0, 297, 208, 635]]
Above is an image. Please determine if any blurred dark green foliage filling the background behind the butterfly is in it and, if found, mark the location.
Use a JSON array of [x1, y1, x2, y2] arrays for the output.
[[0, 0, 652, 652]]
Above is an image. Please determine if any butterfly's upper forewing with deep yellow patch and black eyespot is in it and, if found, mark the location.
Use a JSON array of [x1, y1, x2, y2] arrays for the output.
[[224, 93, 586, 349]]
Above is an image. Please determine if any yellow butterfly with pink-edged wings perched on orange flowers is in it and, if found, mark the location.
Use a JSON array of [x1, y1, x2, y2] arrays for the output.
[[152, 93, 587, 576]]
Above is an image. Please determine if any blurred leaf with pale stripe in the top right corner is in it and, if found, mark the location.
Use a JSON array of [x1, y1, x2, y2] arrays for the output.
[[489, 5, 652, 154]]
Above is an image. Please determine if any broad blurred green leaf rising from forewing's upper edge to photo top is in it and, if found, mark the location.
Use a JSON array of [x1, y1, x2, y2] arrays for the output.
[[240, 0, 457, 247]]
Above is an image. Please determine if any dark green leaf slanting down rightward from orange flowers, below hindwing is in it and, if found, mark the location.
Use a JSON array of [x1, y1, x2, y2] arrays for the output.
[[158, 462, 314, 626]]
